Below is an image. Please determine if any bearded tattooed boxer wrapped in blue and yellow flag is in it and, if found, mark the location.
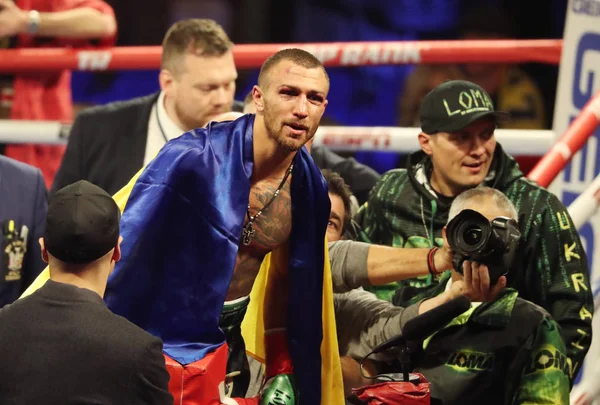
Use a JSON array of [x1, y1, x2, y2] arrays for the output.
[[24, 49, 343, 405]]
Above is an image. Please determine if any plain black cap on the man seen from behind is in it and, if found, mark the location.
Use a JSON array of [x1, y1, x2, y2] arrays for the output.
[[44, 180, 121, 264]]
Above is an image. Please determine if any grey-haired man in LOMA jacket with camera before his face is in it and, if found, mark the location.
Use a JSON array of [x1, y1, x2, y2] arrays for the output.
[[396, 187, 570, 405]]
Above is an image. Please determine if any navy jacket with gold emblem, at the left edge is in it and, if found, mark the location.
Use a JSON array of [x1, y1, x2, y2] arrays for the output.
[[0, 155, 48, 307]]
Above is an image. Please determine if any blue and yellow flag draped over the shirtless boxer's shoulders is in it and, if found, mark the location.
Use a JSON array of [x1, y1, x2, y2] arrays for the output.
[[21, 115, 343, 405]]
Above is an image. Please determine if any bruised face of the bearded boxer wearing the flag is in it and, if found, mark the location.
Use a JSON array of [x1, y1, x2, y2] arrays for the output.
[[259, 60, 329, 152]]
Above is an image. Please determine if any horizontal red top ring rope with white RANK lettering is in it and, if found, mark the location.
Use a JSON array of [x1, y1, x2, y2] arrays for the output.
[[0, 39, 562, 73]]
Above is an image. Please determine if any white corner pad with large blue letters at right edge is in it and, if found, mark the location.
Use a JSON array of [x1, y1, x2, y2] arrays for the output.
[[550, 0, 600, 392]]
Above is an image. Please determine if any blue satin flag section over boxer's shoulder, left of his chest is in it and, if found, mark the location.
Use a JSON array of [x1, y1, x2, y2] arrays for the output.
[[105, 119, 253, 364]]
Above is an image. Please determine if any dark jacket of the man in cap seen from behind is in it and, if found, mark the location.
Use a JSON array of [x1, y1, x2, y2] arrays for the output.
[[0, 280, 173, 405]]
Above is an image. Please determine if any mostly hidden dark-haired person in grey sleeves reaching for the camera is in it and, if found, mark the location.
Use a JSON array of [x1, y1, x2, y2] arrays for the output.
[[322, 170, 506, 397]]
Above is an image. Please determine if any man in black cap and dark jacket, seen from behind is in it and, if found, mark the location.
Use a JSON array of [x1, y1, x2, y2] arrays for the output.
[[0, 181, 173, 405]]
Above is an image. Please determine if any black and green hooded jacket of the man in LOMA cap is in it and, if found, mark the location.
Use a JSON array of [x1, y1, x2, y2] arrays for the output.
[[356, 144, 593, 382]]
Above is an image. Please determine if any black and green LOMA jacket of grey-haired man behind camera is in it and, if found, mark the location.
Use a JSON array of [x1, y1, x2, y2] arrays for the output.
[[404, 272, 570, 405]]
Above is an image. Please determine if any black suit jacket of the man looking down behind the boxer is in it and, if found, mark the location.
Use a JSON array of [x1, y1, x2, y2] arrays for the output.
[[50, 93, 159, 195]]
